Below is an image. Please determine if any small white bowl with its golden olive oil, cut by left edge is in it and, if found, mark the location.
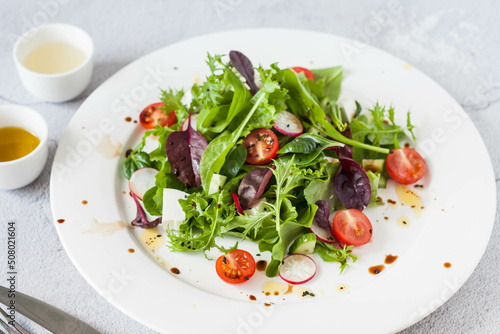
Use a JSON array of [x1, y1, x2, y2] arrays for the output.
[[0, 105, 48, 190]]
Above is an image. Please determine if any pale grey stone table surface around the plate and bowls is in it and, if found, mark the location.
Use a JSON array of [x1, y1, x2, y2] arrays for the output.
[[0, 0, 500, 334]]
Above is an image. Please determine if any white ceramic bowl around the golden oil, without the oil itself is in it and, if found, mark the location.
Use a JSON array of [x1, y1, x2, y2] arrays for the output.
[[0, 104, 49, 190]]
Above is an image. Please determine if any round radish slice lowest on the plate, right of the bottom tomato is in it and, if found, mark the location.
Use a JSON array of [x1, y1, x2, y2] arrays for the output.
[[280, 254, 316, 284]]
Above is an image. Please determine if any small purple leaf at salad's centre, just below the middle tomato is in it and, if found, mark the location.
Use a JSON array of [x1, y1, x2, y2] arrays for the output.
[[238, 166, 276, 210]]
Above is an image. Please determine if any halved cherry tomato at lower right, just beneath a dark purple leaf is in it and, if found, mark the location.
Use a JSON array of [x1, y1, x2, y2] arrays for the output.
[[332, 209, 373, 246]]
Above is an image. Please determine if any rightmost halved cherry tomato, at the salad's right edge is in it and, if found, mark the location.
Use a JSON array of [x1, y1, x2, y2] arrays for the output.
[[386, 147, 426, 184]]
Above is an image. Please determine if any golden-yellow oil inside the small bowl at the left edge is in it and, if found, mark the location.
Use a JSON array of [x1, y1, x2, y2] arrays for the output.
[[0, 127, 40, 162]]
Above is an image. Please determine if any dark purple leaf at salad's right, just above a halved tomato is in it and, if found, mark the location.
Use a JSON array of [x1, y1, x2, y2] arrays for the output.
[[333, 155, 372, 211]]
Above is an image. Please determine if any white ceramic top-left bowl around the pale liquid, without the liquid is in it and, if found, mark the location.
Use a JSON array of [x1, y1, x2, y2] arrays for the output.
[[13, 23, 94, 102]]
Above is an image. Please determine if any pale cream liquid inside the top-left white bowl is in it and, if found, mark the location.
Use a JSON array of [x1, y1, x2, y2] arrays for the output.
[[23, 43, 85, 74]]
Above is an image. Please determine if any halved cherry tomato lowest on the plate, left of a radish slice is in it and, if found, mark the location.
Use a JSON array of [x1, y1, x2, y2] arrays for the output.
[[215, 249, 255, 284]]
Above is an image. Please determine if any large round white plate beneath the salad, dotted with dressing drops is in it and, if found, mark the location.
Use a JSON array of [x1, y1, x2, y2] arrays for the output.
[[51, 29, 496, 333]]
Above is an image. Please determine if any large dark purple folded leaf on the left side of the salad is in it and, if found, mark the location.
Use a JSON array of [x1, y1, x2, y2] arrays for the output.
[[165, 117, 208, 187]]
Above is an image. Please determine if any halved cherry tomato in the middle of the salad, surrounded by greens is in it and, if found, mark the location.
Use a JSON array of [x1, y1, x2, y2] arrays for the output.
[[243, 128, 279, 165]]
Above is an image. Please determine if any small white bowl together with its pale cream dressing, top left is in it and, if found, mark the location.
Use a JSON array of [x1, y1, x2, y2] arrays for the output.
[[13, 23, 94, 102]]
